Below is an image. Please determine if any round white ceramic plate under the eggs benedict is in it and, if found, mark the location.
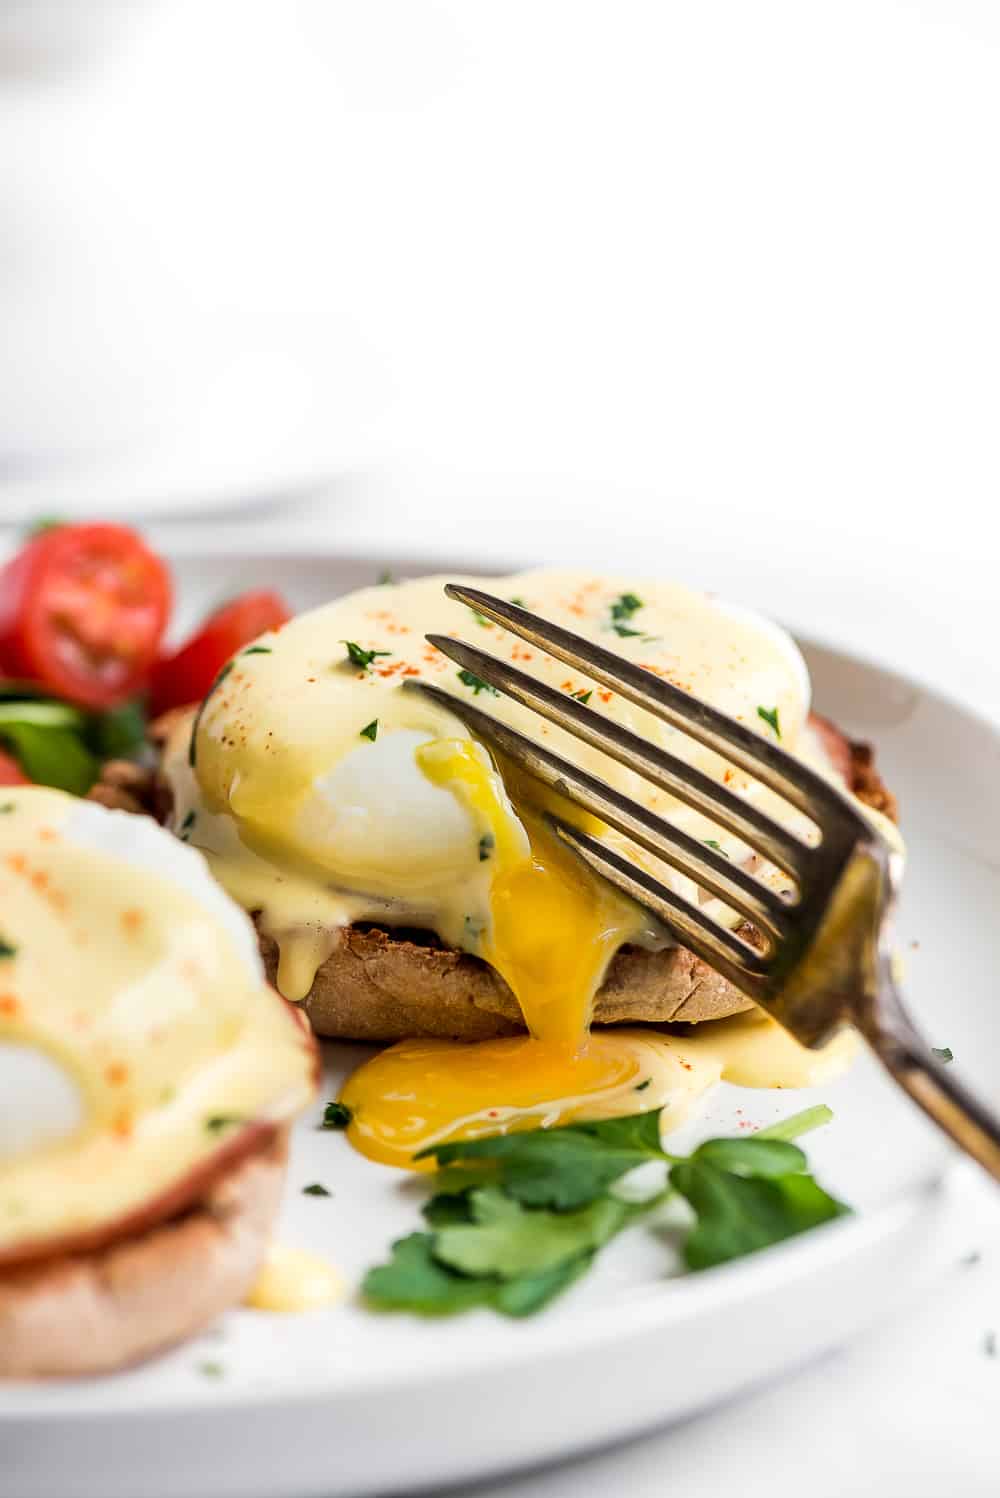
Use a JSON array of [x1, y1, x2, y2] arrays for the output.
[[0, 553, 1000, 1498]]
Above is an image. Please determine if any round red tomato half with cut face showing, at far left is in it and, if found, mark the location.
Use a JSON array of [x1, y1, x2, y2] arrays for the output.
[[0, 524, 171, 707]]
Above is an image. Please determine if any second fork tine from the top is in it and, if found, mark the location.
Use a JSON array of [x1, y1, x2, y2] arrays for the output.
[[427, 635, 813, 887]]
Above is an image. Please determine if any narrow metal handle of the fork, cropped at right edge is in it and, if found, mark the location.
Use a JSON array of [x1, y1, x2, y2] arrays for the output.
[[855, 965, 1000, 1180]]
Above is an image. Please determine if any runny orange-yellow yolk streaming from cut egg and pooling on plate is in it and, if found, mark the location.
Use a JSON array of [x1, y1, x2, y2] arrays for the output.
[[341, 740, 853, 1168]]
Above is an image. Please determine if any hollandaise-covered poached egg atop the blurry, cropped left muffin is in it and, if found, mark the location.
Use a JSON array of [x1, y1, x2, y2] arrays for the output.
[[0, 786, 314, 1261]]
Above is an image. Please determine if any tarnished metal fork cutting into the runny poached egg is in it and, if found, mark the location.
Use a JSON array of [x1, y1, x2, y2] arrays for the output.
[[407, 584, 1000, 1180]]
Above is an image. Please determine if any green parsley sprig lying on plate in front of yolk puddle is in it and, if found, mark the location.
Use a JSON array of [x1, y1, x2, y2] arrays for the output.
[[362, 1107, 849, 1317]]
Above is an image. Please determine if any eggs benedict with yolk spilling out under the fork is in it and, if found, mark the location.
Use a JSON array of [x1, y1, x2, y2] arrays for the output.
[[163, 571, 898, 1164]]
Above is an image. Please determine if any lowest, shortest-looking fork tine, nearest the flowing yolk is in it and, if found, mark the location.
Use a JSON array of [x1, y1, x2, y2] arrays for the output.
[[546, 815, 768, 1002]]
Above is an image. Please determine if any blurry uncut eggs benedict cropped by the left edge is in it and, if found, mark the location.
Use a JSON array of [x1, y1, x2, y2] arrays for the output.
[[0, 788, 316, 1378]]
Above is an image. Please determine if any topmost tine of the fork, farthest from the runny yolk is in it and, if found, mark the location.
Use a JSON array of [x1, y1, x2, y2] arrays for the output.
[[445, 583, 841, 819]]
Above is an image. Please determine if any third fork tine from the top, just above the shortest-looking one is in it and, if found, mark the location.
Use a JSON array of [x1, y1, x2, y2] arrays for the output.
[[406, 682, 790, 939]]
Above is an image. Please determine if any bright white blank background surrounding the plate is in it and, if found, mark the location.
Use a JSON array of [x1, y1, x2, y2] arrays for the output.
[[0, 0, 1000, 1498]]
